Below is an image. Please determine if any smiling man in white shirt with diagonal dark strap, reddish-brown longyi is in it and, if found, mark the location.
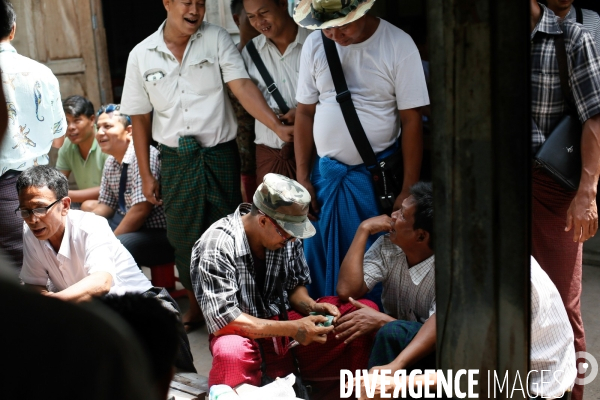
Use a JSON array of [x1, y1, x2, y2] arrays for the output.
[[242, 0, 310, 182]]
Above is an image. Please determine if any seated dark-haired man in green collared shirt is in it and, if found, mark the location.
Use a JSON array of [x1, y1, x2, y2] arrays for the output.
[[56, 96, 108, 203]]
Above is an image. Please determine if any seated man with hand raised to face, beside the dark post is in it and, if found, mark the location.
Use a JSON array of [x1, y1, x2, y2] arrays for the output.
[[335, 182, 436, 369]]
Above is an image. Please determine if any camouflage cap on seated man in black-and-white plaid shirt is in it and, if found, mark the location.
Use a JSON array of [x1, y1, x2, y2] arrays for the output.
[[253, 174, 316, 239]]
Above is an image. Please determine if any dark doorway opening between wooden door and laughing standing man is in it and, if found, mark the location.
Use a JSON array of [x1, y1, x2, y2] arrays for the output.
[[102, 0, 167, 103]]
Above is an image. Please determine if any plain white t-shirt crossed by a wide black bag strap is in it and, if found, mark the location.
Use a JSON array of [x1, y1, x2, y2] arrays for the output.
[[296, 20, 429, 165]]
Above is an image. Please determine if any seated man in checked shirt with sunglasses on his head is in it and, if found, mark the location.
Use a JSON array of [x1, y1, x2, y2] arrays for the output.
[[82, 104, 175, 267]]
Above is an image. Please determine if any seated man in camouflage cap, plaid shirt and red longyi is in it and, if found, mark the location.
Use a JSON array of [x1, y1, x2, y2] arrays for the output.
[[191, 174, 377, 393]]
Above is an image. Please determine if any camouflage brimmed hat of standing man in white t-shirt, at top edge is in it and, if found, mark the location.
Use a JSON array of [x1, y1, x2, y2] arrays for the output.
[[294, 0, 375, 29]]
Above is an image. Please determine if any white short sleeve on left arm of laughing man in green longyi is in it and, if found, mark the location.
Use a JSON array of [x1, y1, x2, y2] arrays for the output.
[[121, 49, 153, 115]]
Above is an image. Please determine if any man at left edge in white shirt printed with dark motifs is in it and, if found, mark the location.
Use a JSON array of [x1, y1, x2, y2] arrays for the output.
[[0, 0, 67, 266]]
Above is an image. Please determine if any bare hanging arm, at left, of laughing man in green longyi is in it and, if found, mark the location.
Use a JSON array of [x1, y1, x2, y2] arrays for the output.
[[131, 113, 162, 204]]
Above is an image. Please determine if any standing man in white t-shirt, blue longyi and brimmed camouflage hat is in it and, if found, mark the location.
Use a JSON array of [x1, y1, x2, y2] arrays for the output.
[[294, 0, 429, 297]]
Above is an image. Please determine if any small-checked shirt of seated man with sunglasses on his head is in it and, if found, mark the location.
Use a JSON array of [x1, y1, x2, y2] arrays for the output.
[[98, 141, 167, 229]]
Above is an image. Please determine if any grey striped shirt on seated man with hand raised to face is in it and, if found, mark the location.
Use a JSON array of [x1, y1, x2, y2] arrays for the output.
[[363, 235, 436, 322]]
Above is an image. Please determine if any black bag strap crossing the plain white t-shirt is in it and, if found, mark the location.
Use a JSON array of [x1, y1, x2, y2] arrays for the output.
[[321, 31, 379, 168]]
